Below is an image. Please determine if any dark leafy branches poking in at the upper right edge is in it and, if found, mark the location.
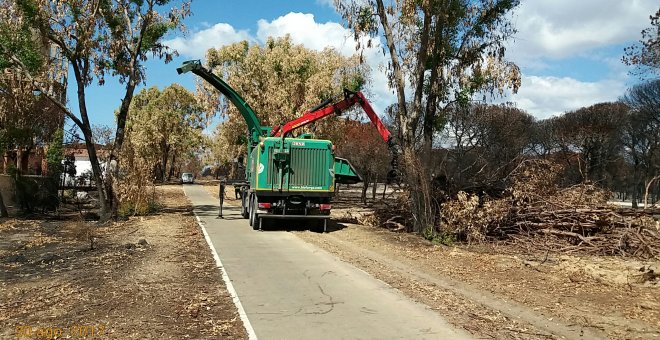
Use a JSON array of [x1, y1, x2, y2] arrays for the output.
[[622, 8, 660, 76]]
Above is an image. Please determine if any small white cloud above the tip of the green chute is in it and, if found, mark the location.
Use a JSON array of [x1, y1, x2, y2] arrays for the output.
[[164, 23, 254, 59]]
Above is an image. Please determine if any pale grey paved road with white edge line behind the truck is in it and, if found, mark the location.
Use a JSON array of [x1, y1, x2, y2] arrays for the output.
[[184, 185, 470, 339]]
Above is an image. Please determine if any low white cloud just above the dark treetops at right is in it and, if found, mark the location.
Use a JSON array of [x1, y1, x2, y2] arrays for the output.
[[508, 76, 625, 119]]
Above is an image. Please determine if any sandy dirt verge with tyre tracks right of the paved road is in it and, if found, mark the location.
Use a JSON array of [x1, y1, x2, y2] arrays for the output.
[[206, 183, 660, 339]]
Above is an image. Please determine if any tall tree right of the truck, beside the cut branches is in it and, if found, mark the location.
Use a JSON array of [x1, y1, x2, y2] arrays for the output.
[[335, 0, 520, 231]]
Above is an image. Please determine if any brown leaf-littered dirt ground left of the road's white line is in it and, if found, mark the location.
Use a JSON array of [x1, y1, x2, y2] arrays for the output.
[[0, 185, 247, 339]]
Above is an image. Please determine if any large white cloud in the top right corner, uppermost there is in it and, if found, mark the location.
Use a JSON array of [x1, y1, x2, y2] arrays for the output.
[[509, 0, 658, 63]]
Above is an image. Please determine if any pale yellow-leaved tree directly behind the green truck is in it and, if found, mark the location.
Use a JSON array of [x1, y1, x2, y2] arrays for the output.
[[198, 36, 368, 163]]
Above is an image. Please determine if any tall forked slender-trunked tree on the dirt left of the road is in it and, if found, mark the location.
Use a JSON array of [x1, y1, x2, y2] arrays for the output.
[[2, 0, 189, 220]]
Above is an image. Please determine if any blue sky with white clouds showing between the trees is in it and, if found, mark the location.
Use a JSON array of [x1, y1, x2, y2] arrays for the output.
[[68, 0, 658, 131]]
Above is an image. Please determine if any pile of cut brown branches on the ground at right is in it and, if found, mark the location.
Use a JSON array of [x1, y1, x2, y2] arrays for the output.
[[439, 160, 660, 258]]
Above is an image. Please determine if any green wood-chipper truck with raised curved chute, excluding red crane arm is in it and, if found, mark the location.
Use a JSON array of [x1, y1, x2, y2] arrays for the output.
[[177, 61, 361, 230]]
